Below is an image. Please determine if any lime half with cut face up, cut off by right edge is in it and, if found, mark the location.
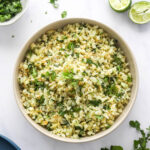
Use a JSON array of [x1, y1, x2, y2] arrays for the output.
[[129, 1, 150, 24]]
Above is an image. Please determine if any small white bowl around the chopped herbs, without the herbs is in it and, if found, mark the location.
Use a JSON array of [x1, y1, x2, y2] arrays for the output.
[[0, 0, 29, 26]]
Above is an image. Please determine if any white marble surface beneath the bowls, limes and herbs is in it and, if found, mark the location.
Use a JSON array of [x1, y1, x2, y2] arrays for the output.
[[0, 0, 150, 150]]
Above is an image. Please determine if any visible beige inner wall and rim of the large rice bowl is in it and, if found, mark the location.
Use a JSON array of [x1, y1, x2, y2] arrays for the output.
[[14, 18, 138, 143]]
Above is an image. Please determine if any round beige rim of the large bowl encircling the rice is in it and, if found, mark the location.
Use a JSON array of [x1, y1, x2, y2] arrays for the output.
[[13, 18, 139, 143]]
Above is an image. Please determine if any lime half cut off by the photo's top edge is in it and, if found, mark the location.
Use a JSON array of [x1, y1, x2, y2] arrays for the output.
[[109, 0, 132, 12]]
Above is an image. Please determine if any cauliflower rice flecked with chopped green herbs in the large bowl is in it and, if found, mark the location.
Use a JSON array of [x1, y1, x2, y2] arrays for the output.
[[18, 23, 132, 139]]
